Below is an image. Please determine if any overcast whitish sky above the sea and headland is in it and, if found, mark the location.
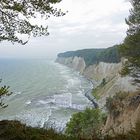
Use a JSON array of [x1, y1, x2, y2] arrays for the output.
[[0, 0, 131, 59]]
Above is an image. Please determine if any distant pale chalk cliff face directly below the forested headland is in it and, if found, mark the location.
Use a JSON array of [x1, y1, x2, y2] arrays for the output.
[[56, 56, 121, 82]]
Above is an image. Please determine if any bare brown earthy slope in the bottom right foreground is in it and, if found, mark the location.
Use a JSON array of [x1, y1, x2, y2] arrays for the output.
[[103, 92, 140, 135]]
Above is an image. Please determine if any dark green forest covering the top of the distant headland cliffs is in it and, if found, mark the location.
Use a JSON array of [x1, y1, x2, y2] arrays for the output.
[[58, 45, 121, 66]]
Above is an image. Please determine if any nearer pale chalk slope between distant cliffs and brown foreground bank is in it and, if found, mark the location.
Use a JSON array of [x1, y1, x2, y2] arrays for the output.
[[96, 74, 137, 108]]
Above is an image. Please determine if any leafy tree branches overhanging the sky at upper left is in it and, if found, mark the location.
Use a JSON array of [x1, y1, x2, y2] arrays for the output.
[[0, 0, 65, 45]]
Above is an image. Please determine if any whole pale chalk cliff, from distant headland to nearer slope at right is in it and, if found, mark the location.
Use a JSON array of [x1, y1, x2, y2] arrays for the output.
[[56, 56, 137, 101]]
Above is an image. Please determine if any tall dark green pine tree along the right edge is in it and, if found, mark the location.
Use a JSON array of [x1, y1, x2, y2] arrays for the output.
[[120, 0, 140, 83]]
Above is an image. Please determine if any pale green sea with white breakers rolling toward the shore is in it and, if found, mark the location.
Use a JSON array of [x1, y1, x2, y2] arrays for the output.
[[0, 59, 92, 129]]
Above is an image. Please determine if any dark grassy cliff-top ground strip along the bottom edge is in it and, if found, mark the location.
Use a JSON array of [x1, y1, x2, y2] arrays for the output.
[[0, 118, 140, 140]]
